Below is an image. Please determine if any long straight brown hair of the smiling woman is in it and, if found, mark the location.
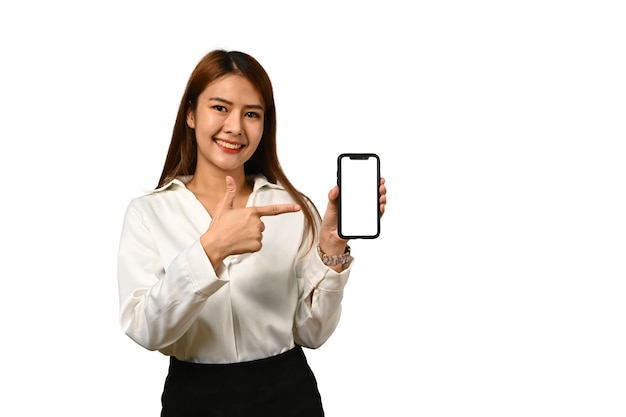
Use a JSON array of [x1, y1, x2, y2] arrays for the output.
[[157, 49, 319, 243]]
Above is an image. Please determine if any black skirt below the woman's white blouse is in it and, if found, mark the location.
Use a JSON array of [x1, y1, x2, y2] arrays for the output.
[[161, 346, 324, 417]]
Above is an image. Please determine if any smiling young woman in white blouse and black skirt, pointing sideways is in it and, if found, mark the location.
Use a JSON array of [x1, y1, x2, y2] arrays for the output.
[[118, 50, 387, 417]]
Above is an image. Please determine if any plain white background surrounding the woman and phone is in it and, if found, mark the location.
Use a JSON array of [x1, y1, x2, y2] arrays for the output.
[[0, 0, 626, 417]]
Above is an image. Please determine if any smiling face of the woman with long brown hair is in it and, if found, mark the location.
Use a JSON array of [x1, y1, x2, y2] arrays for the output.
[[187, 75, 264, 175]]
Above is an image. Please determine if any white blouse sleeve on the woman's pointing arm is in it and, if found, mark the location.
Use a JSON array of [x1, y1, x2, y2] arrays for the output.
[[118, 203, 227, 350]]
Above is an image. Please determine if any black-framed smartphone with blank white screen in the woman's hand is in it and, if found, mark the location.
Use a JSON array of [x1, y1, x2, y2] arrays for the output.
[[337, 153, 380, 239]]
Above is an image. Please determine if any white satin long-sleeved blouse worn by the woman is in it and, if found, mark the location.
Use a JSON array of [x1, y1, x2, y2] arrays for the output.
[[118, 175, 351, 363]]
